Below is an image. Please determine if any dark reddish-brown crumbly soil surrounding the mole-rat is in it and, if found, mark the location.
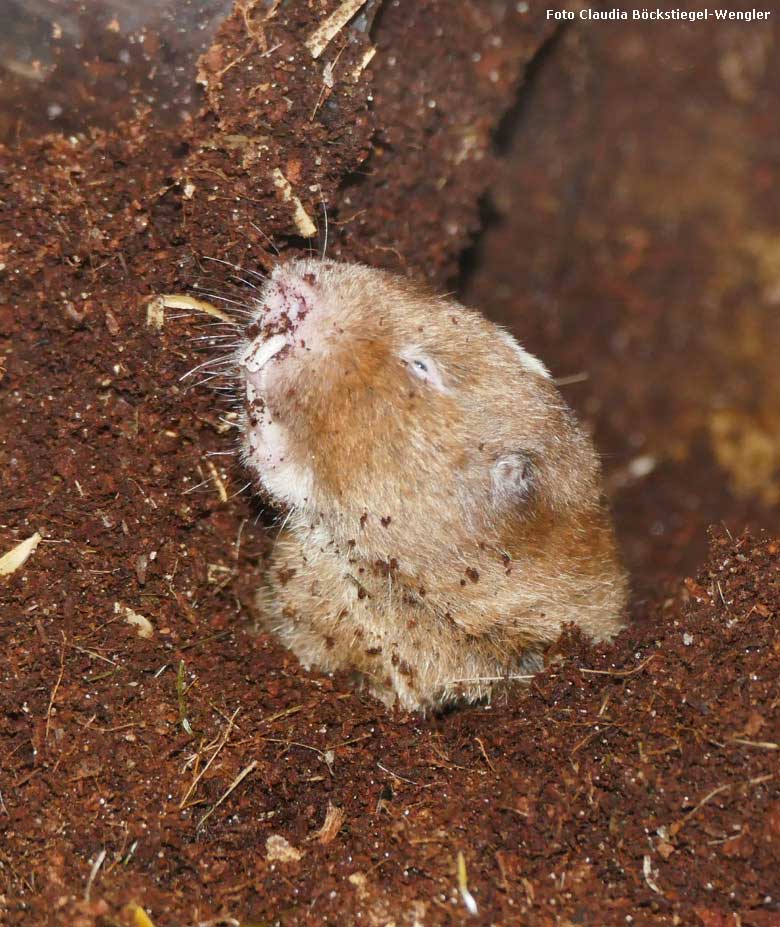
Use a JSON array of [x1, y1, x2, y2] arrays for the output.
[[0, 0, 780, 927]]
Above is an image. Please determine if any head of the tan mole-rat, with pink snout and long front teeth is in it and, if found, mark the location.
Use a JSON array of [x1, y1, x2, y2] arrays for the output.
[[239, 259, 597, 543]]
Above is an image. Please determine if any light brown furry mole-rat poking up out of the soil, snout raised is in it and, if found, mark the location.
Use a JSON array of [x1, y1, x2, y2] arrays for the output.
[[237, 258, 626, 711]]
